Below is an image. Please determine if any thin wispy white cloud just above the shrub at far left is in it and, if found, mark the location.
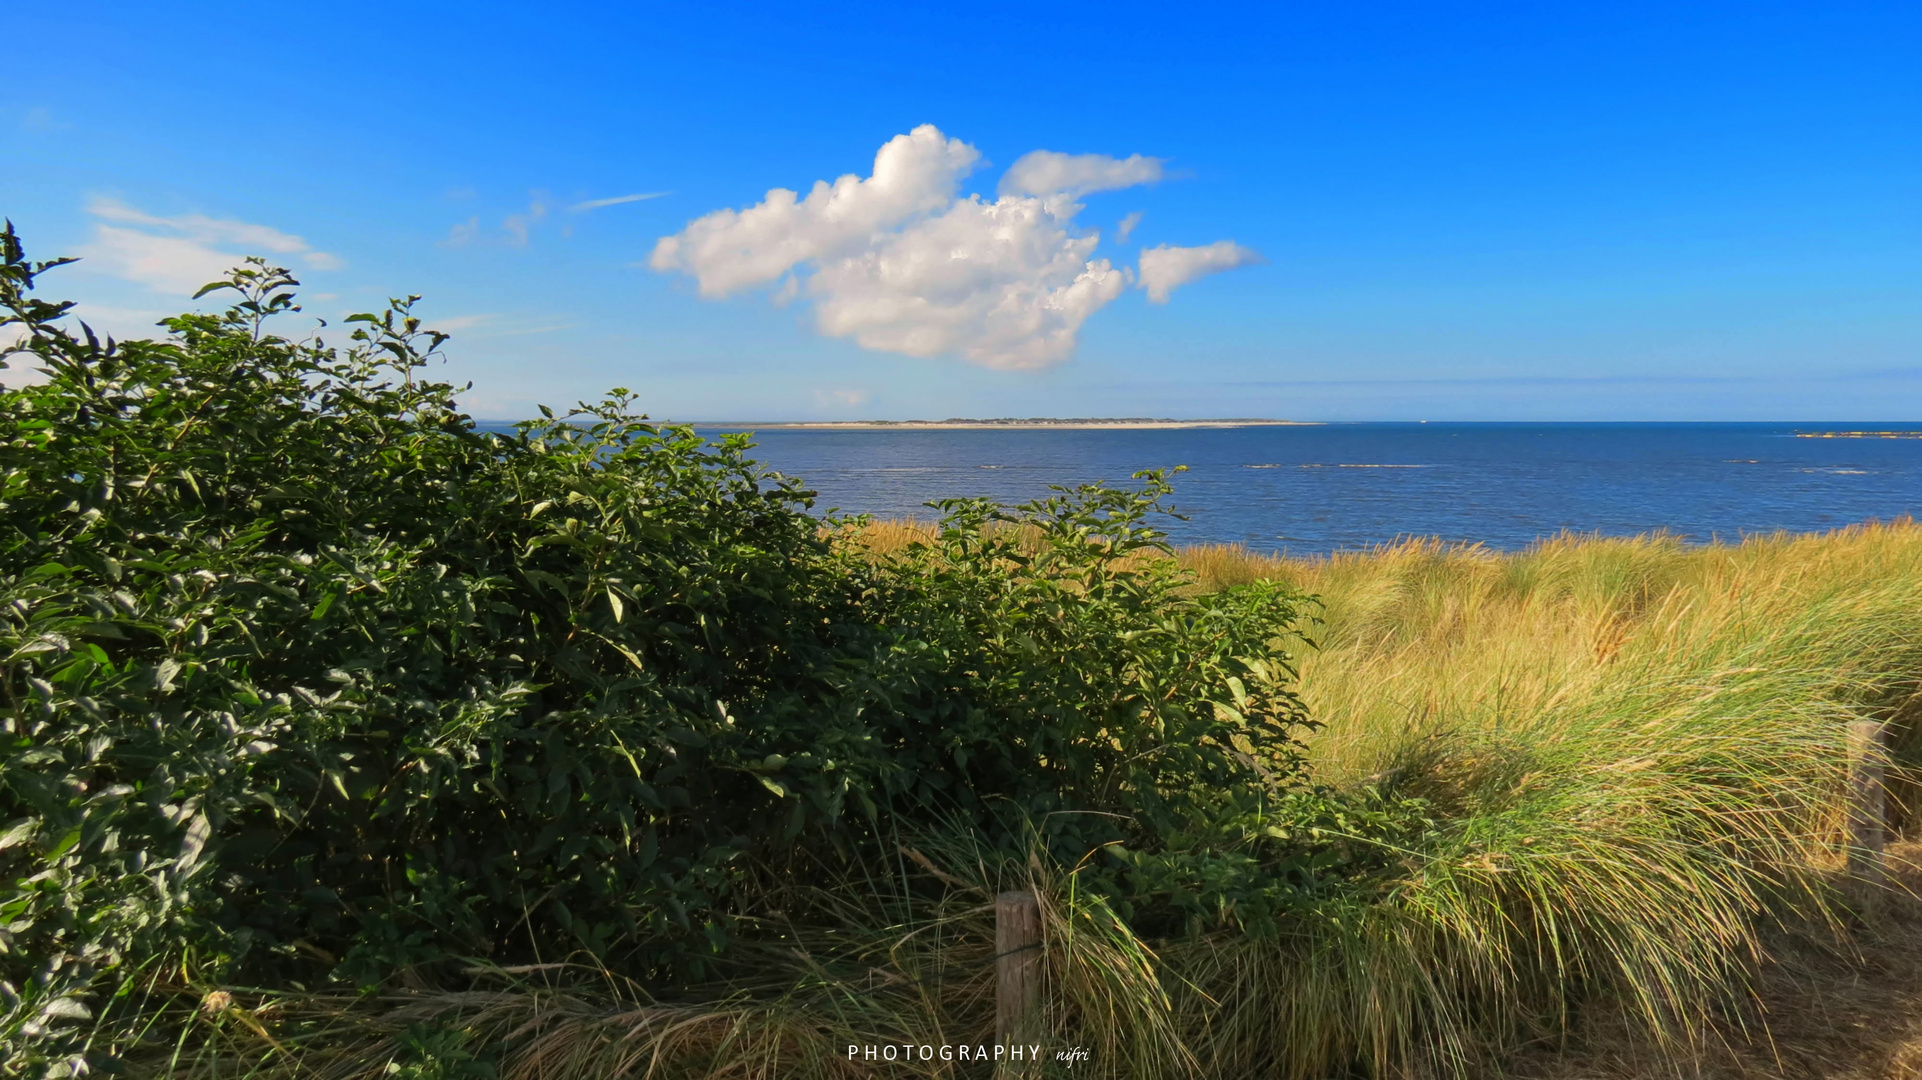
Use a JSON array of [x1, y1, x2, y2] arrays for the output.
[[81, 198, 346, 296]]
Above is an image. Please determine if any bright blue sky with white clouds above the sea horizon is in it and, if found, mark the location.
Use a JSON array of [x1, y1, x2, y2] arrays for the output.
[[0, 2, 1922, 421]]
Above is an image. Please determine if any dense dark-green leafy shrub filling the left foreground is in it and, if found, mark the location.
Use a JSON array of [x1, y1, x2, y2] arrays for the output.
[[0, 227, 1317, 1070]]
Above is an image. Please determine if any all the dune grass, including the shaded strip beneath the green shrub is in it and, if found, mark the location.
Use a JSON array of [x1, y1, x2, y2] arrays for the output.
[[142, 521, 1922, 1080]]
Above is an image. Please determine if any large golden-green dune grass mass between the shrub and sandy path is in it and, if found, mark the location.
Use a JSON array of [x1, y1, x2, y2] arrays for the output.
[[1153, 523, 1922, 1074]]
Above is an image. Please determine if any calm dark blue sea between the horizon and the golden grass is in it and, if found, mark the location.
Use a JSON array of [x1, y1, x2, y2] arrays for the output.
[[695, 423, 1922, 553]]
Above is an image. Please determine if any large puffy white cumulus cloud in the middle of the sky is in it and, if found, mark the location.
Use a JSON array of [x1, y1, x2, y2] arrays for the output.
[[648, 125, 1253, 369]]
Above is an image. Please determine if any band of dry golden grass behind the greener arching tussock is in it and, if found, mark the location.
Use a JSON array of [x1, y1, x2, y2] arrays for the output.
[[1178, 521, 1922, 780]]
